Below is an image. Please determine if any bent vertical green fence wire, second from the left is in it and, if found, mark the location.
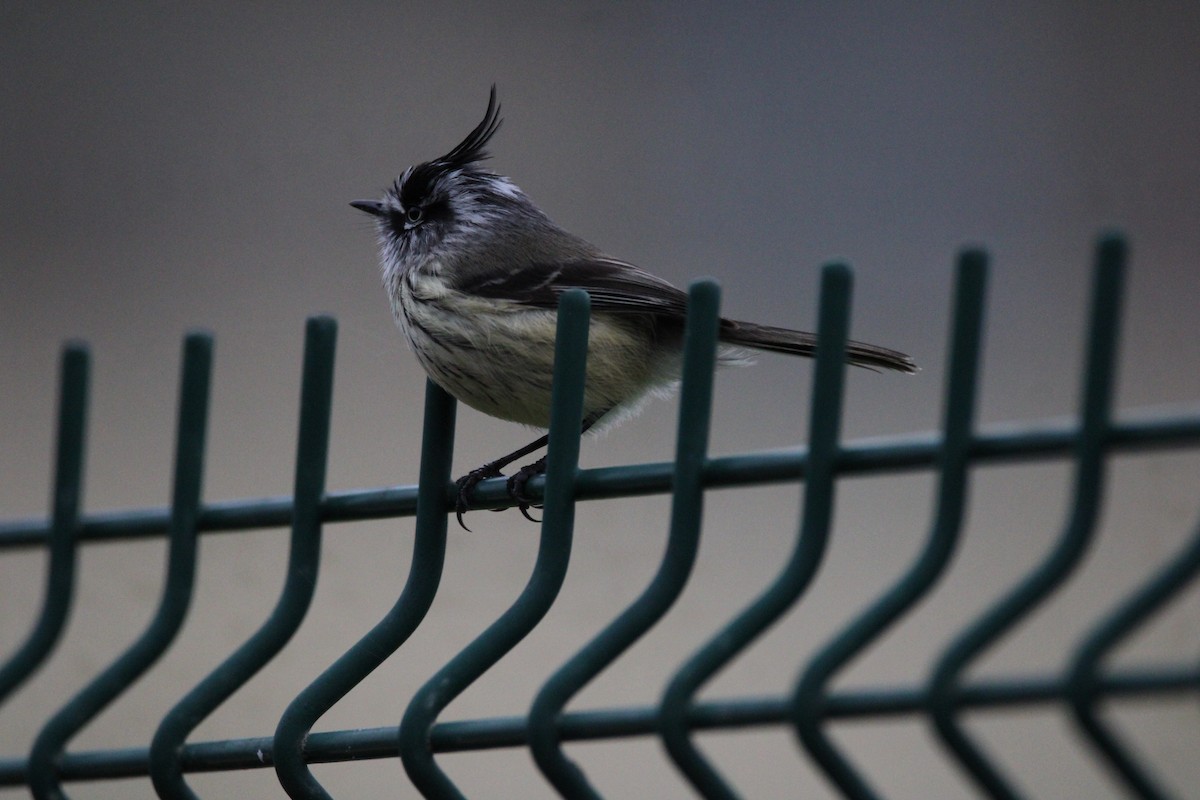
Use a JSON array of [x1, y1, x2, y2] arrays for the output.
[[29, 333, 212, 800]]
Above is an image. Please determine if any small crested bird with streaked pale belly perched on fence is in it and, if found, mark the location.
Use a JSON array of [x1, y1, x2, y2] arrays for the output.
[[350, 85, 917, 528]]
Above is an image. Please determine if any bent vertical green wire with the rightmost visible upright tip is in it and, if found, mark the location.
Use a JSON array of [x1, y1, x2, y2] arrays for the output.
[[929, 235, 1126, 800]]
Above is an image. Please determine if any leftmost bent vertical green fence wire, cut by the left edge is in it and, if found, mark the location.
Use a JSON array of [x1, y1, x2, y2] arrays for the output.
[[0, 342, 89, 704]]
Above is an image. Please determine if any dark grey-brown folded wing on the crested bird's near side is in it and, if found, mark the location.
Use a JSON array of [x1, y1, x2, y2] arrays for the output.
[[455, 257, 688, 318]]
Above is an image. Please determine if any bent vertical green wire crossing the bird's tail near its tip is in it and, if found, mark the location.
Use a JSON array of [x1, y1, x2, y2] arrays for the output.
[[659, 264, 852, 798]]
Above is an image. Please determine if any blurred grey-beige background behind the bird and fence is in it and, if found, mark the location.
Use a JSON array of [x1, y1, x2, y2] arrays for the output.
[[0, 2, 1200, 798]]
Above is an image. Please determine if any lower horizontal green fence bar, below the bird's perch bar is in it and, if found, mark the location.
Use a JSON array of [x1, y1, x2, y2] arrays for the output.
[[0, 667, 1200, 786]]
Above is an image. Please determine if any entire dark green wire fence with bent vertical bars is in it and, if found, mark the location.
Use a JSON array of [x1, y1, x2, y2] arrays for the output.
[[0, 235, 1200, 800]]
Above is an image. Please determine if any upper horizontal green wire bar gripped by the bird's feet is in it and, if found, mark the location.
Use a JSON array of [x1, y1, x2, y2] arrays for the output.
[[0, 409, 1200, 551]]
